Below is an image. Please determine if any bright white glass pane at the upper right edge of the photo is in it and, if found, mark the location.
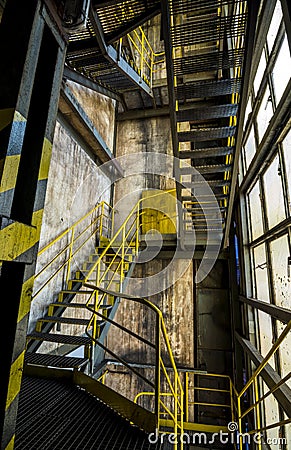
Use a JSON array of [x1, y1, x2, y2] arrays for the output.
[[273, 34, 291, 105]]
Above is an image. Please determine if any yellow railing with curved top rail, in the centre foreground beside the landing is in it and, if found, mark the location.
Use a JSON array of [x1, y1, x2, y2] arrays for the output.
[[84, 283, 184, 449]]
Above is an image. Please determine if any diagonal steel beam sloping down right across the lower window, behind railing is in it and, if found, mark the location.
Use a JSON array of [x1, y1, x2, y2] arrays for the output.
[[235, 332, 291, 417]]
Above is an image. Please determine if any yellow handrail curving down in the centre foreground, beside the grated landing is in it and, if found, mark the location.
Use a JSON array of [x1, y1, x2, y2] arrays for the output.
[[83, 283, 184, 449]]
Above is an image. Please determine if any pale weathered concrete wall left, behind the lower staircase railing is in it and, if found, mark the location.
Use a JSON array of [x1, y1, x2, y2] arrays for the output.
[[30, 119, 110, 330]]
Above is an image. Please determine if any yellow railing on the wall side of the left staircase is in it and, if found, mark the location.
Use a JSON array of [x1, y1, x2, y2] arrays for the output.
[[33, 201, 114, 298]]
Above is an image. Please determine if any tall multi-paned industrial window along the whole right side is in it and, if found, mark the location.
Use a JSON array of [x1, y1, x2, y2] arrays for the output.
[[240, 0, 291, 442]]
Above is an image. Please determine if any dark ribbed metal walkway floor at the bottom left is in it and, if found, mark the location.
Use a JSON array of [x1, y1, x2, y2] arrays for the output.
[[14, 376, 161, 450]]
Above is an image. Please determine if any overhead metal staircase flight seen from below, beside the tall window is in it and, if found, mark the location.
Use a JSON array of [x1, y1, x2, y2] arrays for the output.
[[162, 0, 248, 246]]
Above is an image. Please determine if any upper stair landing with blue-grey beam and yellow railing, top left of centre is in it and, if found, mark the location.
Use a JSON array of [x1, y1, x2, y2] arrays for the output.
[[62, 0, 160, 96]]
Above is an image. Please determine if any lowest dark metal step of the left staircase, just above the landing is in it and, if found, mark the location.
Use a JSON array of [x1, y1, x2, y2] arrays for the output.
[[24, 352, 89, 369]]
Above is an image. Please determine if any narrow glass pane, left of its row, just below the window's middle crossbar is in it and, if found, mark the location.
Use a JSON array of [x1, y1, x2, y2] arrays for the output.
[[254, 244, 270, 302]]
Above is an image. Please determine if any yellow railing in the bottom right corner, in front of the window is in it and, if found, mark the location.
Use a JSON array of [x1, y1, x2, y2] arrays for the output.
[[236, 321, 291, 450]]
